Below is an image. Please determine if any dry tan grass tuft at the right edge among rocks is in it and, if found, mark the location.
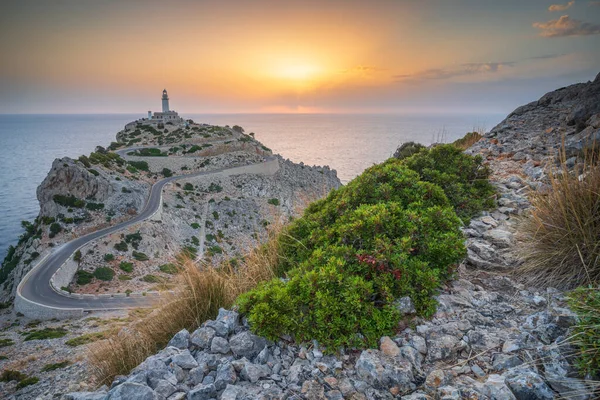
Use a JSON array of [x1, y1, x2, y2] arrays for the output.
[[518, 147, 600, 289]]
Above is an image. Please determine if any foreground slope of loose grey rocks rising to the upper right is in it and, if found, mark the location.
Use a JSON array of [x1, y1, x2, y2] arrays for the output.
[[65, 75, 600, 400]]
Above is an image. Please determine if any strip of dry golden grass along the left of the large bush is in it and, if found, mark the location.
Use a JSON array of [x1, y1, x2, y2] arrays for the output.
[[88, 219, 283, 385]]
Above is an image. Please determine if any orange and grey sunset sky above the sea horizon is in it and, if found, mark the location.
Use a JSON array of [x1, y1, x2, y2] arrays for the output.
[[0, 0, 600, 114]]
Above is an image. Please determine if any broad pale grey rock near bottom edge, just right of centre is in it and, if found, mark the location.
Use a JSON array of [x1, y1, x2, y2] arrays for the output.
[[355, 349, 415, 393]]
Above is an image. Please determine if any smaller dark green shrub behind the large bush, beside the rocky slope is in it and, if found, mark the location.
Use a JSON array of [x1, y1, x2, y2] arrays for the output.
[[404, 144, 496, 222]]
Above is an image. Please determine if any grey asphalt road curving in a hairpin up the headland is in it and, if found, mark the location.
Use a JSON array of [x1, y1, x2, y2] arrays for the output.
[[17, 156, 276, 311]]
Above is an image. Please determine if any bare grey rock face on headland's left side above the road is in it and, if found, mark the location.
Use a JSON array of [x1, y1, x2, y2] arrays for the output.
[[37, 157, 115, 217]]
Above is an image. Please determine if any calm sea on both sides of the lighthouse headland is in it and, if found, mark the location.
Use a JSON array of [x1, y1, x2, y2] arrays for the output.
[[0, 113, 505, 260]]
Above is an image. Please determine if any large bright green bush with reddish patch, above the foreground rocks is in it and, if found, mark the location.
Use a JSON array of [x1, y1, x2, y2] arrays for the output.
[[238, 159, 465, 349]]
